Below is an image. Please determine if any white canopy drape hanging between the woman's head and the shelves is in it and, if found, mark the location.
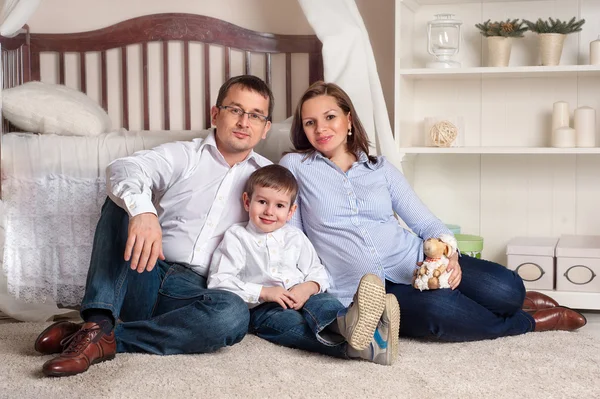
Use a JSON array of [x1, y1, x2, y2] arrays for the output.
[[298, 0, 402, 170]]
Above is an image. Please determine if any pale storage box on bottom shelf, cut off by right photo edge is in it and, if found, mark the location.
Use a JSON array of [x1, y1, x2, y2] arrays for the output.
[[556, 236, 600, 292]]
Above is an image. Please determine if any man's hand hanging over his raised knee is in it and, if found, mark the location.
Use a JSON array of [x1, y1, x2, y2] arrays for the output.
[[124, 213, 165, 273]]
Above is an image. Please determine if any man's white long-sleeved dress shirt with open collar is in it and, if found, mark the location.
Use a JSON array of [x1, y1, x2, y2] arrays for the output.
[[106, 129, 271, 276]]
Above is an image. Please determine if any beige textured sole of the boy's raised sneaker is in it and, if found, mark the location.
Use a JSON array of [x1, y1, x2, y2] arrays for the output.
[[348, 274, 385, 351]]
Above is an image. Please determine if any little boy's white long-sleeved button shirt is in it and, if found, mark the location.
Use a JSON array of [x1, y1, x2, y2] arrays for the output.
[[208, 222, 329, 308]]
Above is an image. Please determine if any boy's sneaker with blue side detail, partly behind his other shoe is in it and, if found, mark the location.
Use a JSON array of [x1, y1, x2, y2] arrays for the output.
[[348, 294, 400, 366]]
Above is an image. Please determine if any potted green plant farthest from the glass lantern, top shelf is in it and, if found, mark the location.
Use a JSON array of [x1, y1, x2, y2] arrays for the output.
[[523, 17, 585, 65]]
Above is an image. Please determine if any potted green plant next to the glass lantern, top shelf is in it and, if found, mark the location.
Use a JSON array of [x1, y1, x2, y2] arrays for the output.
[[475, 19, 529, 67]]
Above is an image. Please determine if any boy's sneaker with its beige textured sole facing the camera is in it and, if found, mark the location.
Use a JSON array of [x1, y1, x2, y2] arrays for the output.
[[337, 274, 385, 351]]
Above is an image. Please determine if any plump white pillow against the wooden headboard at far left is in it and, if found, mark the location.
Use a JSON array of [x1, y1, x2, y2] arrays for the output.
[[2, 82, 112, 136]]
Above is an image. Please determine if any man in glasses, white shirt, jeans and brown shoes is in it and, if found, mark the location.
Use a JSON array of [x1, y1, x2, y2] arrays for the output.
[[35, 75, 273, 376]]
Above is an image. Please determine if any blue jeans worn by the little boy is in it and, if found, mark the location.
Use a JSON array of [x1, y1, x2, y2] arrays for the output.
[[249, 293, 348, 358]]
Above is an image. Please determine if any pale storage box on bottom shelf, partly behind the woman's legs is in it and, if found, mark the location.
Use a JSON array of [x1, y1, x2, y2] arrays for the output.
[[506, 237, 558, 290]]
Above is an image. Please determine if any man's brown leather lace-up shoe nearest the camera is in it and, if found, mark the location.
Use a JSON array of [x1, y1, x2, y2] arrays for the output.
[[42, 323, 117, 377]]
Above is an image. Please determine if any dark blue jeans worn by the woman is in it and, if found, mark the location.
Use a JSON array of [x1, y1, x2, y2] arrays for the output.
[[386, 255, 535, 341]]
